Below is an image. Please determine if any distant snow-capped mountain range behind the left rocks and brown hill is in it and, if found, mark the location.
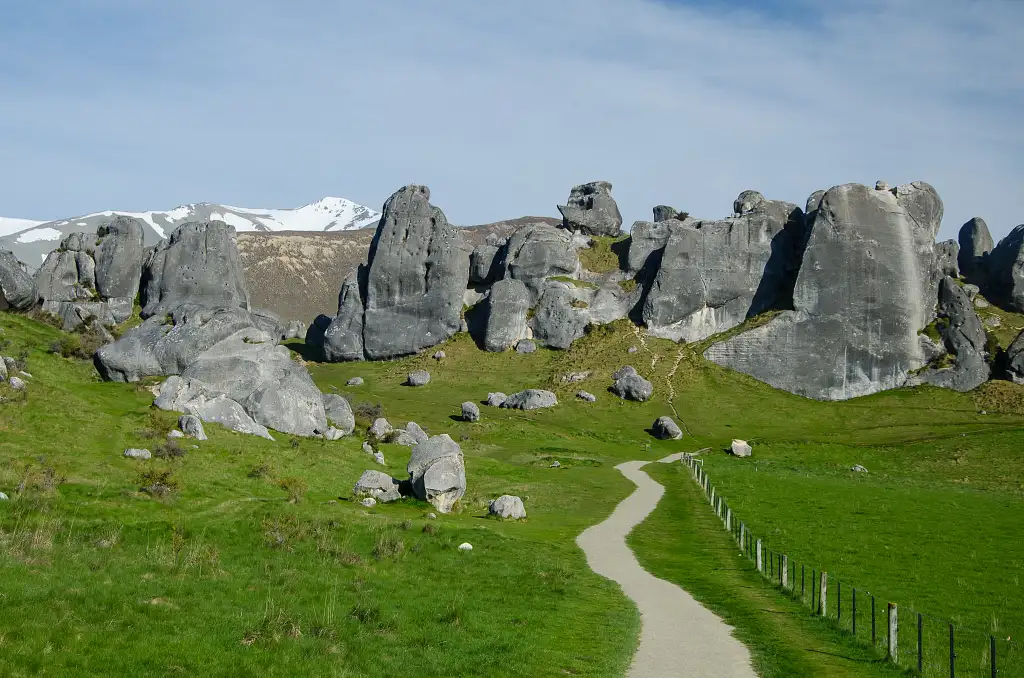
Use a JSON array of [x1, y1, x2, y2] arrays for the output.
[[0, 198, 381, 267]]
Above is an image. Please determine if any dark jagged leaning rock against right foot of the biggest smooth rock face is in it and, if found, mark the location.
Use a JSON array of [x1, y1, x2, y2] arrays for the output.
[[922, 277, 990, 391]]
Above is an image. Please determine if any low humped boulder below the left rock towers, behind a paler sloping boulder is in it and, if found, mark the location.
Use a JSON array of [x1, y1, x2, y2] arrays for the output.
[[94, 304, 276, 381]]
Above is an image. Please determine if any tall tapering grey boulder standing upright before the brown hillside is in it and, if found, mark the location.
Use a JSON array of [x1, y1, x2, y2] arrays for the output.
[[362, 184, 470, 359]]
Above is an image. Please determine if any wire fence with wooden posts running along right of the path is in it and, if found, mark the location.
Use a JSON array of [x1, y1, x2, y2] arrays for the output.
[[682, 455, 1024, 678]]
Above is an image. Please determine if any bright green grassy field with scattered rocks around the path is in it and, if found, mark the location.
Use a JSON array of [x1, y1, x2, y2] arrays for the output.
[[0, 314, 1024, 676]]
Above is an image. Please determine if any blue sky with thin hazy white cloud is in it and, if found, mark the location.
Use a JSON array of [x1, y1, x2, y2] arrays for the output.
[[0, 0, 1024, 239]]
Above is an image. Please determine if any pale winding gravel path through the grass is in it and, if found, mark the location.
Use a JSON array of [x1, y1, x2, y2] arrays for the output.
[[577, 454, 757, 678]]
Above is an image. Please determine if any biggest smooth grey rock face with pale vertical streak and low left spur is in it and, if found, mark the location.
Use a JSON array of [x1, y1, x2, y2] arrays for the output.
[[705, 182, 942, 400]]
